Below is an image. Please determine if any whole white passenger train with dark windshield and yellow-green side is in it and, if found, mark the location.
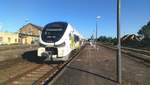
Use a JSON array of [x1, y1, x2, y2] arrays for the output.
[[37, 21, 84, 61]]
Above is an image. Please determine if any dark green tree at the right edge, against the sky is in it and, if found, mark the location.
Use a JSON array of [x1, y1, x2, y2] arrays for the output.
[[138, 21, 150, 39]]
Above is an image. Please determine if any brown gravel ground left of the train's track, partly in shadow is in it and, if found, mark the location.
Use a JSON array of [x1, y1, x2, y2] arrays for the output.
[[0, 47, 40, 83]]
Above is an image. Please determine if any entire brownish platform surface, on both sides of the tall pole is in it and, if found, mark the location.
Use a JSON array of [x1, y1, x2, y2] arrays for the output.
[[50, 45, 150, 85]]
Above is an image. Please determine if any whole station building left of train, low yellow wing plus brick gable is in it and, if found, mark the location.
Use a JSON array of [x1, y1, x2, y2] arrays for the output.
[[0, 23, 42, 45]]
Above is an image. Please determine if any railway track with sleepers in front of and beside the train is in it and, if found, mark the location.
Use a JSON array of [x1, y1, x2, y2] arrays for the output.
[[1, 46, 82, 85]]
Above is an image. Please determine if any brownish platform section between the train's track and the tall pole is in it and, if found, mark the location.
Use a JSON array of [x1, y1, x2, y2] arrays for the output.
[[49, 45, 117, 85]]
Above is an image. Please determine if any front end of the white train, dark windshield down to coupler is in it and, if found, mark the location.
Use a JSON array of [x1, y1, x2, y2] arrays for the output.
[[37, 22, 71, 61]]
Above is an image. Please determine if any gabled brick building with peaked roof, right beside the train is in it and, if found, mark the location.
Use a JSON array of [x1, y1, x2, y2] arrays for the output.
[[19, 23, 42, 44]]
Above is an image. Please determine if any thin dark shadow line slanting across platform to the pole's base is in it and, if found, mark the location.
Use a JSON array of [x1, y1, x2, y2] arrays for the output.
[[67, 66, 118, 83]]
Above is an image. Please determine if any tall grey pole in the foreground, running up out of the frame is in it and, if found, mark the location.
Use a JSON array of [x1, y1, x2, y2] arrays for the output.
[[117, 0, 122, 84]]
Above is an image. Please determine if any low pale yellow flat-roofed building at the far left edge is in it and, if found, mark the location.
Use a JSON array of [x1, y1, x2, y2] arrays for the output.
[[0, 32, 19, 44]]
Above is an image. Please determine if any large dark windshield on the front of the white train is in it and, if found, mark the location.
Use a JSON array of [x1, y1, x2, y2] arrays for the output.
[[42, 22, 67, 43]]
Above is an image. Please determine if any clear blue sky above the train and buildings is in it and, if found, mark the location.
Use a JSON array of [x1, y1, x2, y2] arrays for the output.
[[0, 0, 150, 38]]
